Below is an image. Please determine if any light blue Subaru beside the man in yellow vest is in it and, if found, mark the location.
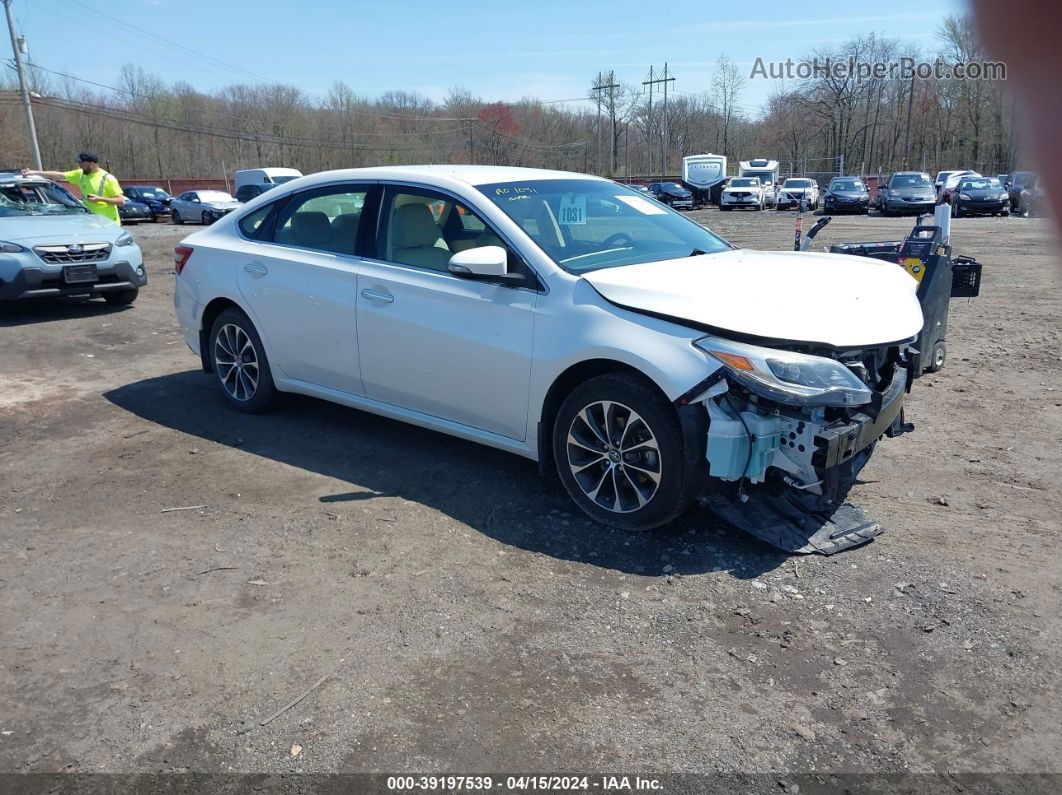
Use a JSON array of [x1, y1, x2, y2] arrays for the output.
[[0, 172, 148, 304]]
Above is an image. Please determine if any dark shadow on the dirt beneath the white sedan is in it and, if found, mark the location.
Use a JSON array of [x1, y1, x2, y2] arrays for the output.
[[104, 370, 788, 578]]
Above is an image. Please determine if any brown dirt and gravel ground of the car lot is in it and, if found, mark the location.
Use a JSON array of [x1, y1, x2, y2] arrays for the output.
[[0, 211, 1062, 792]]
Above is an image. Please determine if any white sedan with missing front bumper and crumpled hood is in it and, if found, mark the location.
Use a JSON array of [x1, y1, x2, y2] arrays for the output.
[[174, 166, 923, 530]]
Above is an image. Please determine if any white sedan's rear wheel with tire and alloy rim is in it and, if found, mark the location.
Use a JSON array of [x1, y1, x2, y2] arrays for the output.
[[209, 309, 277, 414]]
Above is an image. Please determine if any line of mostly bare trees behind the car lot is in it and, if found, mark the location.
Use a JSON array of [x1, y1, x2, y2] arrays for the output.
[[0, 16, 1025, 178]]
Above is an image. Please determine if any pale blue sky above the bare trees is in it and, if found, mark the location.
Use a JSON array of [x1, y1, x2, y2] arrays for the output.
[[13, 0, 966, 114]]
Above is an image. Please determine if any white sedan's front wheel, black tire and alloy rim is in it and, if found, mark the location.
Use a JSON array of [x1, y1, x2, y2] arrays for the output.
[[553, 374, 692, 532]]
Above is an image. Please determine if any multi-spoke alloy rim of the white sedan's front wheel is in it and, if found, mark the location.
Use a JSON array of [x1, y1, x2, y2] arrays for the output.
[[567, 400, 662, 514]]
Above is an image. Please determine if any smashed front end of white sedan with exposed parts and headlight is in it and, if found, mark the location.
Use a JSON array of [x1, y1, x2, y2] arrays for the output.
[[676, 335, 912, 554]]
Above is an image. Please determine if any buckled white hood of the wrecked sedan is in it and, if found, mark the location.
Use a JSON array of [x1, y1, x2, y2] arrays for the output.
[[583, 249, 922, 348]]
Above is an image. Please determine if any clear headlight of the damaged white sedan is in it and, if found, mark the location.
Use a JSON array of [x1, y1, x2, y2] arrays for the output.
[[693, 336, 873, 405]]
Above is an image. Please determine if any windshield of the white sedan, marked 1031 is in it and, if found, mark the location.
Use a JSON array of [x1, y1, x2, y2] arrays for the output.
[[477, 179, 732, 274]]
